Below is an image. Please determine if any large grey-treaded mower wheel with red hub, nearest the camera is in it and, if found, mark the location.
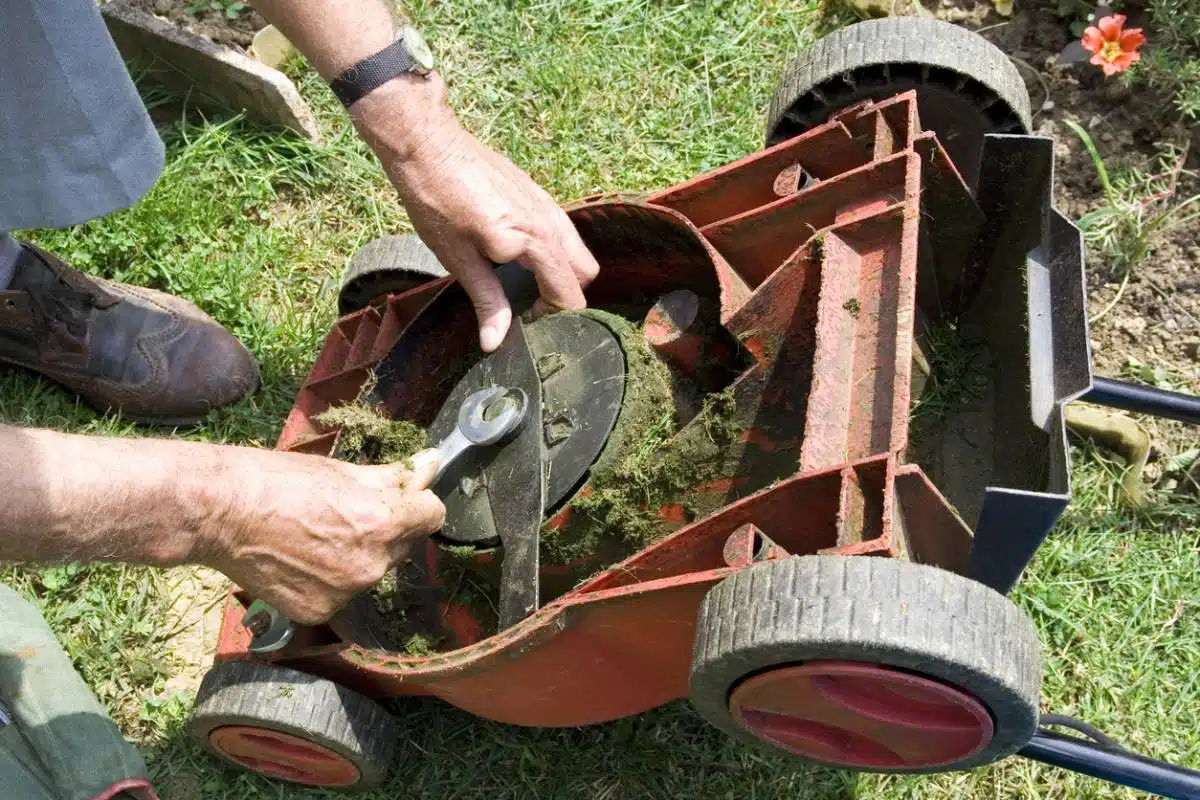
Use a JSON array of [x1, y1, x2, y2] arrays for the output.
[[691, 555, 1042, 772]]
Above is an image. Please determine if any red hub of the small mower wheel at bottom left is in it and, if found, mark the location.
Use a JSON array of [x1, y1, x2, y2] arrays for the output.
[[209, 724, 361, 787]]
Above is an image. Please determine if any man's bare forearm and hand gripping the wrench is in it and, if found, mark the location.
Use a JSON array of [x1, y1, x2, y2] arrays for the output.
[[0, 425, 445, 624]]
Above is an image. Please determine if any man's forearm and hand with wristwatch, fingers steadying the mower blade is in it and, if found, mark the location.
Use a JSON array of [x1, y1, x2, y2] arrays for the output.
[[251, 0, 600, 353]]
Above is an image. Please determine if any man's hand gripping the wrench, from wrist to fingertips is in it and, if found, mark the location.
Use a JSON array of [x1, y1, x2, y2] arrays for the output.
[[208, 450, 445, 625]]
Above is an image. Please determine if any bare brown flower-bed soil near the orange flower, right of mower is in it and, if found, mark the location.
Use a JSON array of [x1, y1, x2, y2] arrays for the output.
[[926, 0, 1200, 470]]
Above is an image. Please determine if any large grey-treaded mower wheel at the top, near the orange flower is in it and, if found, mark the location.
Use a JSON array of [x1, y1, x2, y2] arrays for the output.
[[767, 17, 1031, 188]]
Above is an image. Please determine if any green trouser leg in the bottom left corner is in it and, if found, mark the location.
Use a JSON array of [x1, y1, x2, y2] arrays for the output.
[[0, 583, 154, 800]]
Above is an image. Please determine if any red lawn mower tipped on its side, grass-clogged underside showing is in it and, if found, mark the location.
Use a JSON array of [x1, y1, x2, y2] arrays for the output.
[[190, 18, 1200, 798]]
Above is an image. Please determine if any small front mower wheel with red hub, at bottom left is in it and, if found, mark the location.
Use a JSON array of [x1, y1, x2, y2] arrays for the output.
[[187, 661, 400, 790]]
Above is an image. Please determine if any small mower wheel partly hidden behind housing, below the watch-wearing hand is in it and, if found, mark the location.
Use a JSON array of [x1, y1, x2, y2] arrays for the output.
[[337, 234, 448, 314]]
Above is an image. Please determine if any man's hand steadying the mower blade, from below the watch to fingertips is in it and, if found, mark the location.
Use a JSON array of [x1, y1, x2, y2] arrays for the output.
[[354, 76, 600, 353]]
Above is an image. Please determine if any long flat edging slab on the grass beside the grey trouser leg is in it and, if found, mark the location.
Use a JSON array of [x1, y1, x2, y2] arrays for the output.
[[100, 0, 320, 142]]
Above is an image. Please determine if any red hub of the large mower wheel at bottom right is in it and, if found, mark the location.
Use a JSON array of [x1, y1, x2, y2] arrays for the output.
[[730, 661, 995, 769]]
